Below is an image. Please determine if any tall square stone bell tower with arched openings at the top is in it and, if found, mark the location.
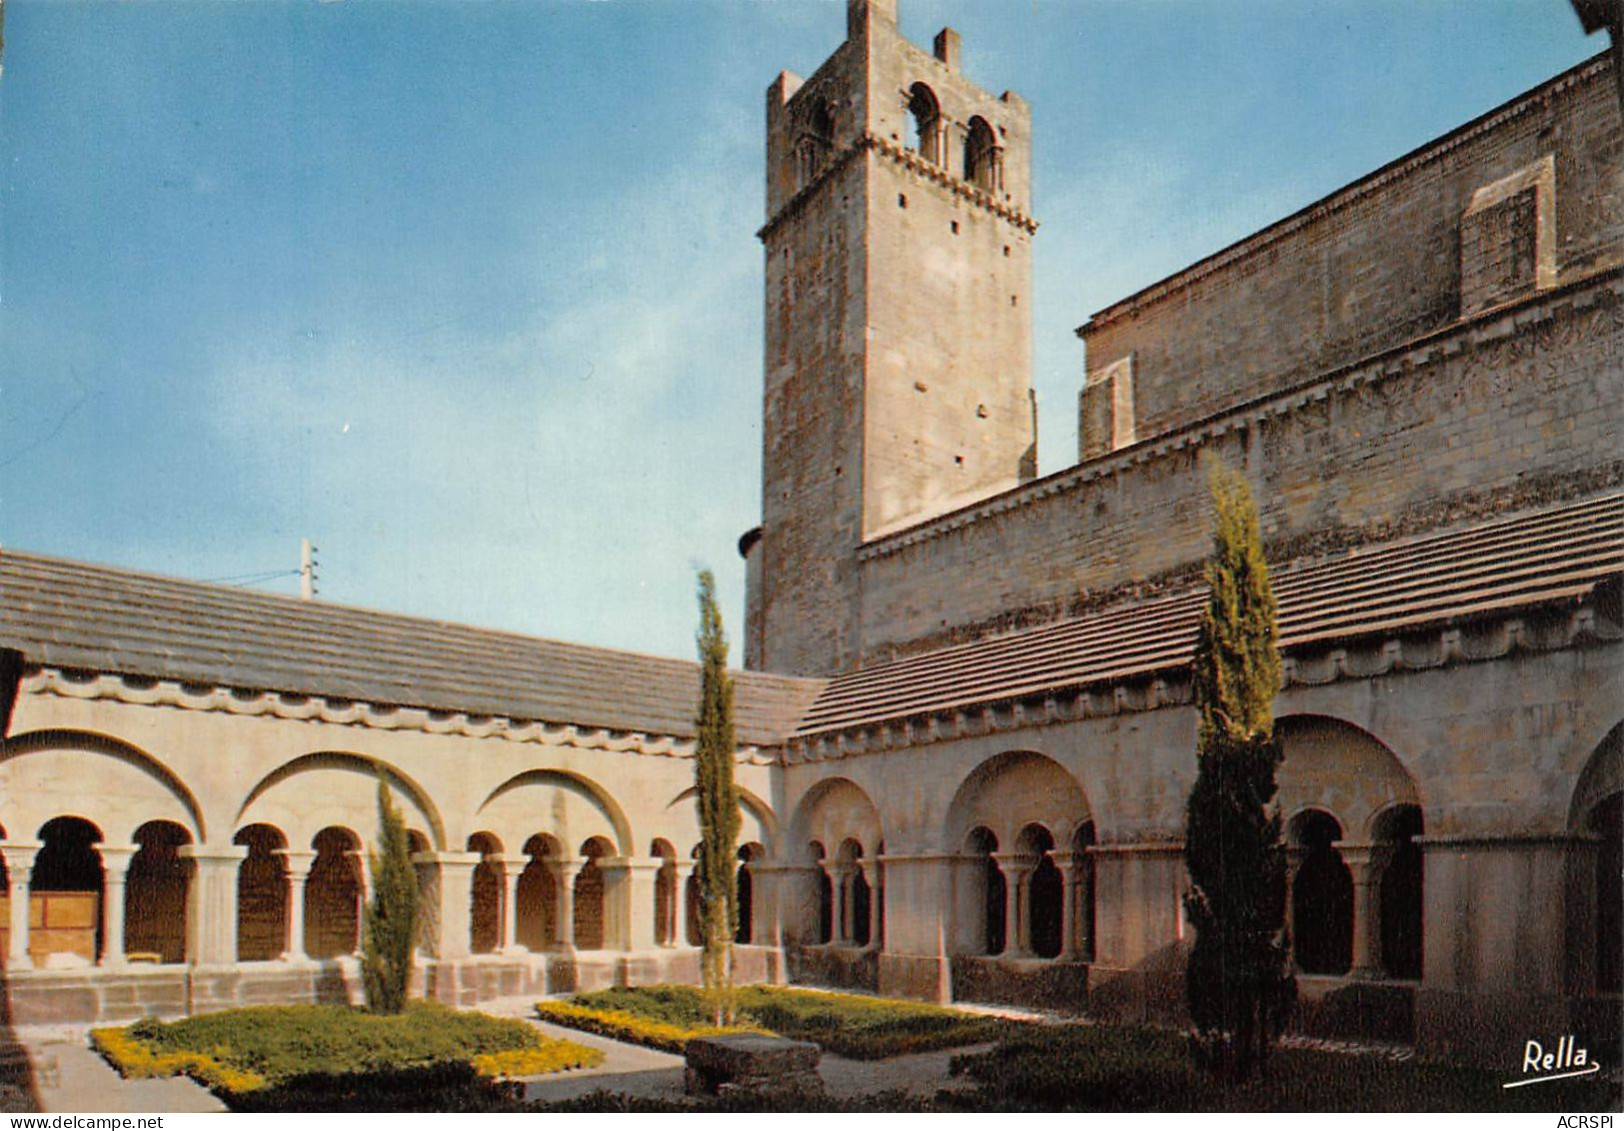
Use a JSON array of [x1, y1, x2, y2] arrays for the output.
[[741, 0, 1036, 674]]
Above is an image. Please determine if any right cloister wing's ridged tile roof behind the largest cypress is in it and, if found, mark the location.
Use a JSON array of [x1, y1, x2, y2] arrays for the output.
[[797, 496, 1624, 736]]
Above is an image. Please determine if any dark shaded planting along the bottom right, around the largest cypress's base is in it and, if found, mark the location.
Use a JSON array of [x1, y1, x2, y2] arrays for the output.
[[939, 1025, 1619, 1112]]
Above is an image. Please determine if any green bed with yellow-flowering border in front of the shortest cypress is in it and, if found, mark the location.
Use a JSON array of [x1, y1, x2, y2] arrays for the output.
[[91, 1001, 603, 1110]]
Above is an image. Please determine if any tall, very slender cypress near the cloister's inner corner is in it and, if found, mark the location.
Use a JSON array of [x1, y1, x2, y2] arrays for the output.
[[693, 569, 739, 1025]]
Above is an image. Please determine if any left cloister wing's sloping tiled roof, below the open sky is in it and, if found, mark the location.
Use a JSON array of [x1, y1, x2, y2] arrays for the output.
[[0, 551, 823, 746]]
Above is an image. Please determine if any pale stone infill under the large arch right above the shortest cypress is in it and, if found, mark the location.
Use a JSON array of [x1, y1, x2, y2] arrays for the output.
[[234, 751, 445, 850]]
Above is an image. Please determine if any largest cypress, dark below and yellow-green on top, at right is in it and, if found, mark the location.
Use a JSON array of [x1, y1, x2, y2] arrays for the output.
[[1184, 465, 1296, 1079]]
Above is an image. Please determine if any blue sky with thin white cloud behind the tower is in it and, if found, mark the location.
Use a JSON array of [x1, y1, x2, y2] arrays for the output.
[[0, 0, 1606, 658]]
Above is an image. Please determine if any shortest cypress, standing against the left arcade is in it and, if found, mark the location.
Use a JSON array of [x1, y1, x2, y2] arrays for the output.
[[361, 775, 417, 1014]]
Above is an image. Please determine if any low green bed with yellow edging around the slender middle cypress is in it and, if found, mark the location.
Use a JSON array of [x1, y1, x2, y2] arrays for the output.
[[538, 986, 1013, 1060]]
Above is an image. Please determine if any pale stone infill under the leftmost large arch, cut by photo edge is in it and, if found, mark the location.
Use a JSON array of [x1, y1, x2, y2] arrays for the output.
[[0, 730, 208, 843]]
